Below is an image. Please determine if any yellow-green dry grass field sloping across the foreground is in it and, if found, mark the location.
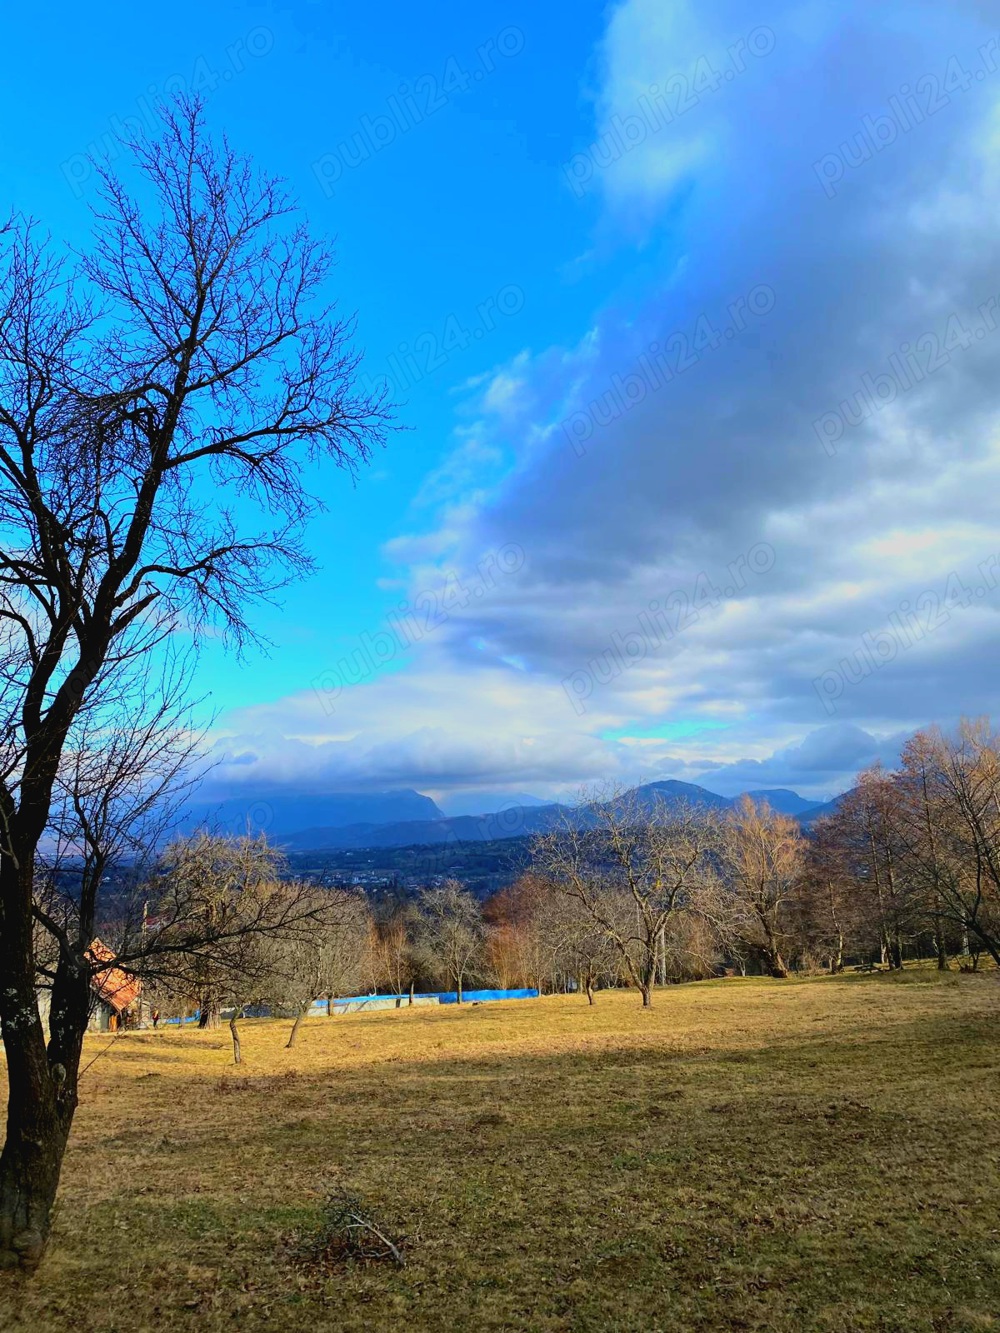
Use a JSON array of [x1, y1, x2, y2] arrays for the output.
[[0, 970, 1000, 1333]]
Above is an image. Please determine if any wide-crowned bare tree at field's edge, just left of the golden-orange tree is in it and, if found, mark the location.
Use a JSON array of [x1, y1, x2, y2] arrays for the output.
[[532, 788, 717, 1009]]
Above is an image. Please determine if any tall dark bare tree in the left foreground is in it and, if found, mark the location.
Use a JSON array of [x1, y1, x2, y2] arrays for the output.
[[0, 96, 384, 1269]]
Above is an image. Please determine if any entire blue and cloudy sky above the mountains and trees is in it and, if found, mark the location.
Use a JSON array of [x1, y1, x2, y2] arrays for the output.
[[0, 0, 1000, 809]]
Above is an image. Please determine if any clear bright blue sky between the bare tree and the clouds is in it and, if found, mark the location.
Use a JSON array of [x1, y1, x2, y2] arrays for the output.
[[3, 4, 608, 704]]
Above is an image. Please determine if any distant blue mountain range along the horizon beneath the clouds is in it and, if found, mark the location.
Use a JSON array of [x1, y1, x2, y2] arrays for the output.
[[185, 780, 840, 852]]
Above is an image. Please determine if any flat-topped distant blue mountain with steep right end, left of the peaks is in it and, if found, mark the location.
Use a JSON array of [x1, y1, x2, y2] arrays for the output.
[[184, 788, 444, 838]]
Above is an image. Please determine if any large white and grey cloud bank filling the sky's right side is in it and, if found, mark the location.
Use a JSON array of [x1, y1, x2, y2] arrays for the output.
[[212, 0, 1000, 792]]
